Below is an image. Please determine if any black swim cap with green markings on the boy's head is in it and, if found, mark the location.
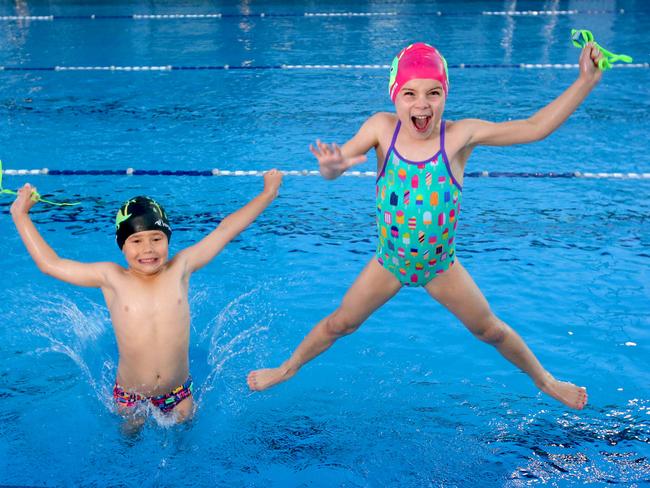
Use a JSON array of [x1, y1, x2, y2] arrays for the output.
[[115, 196, 172, 249]]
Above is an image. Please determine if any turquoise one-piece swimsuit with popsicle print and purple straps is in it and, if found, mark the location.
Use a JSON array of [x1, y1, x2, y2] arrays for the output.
[[376, 121, 462, 286]]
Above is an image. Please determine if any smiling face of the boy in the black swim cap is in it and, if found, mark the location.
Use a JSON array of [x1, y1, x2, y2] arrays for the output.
[[122, 230, 169, 275]]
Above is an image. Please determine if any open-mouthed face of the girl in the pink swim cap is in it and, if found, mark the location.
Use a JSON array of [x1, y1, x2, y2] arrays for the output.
[[395, 78, 445, 139]]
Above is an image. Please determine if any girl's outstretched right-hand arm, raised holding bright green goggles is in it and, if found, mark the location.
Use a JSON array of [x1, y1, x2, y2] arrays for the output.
[[458, 43, 602, 147]]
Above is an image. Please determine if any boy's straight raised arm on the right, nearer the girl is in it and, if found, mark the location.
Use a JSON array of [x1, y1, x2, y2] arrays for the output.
[[176, 169, 282, 273]]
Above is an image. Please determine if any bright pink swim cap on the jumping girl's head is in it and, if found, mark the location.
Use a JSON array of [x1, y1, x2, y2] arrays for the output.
[[388, 42, 449, 102]]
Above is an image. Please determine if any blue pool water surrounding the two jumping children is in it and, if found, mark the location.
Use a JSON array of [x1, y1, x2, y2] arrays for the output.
[[0, 0, 650, 487]]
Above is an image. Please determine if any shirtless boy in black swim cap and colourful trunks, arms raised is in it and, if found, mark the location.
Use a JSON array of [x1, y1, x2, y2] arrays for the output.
[[11, 169, 282, 425]]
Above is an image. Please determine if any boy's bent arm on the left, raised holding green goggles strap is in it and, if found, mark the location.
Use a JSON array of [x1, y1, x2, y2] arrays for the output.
[[11, 183, 108, 288]]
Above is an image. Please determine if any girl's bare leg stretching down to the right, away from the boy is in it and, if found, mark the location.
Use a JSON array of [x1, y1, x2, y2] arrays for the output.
[[425, 261, 587, 409]]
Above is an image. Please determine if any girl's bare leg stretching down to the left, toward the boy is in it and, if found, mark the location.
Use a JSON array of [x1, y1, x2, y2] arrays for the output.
[[247, 258, 401, 390]]
